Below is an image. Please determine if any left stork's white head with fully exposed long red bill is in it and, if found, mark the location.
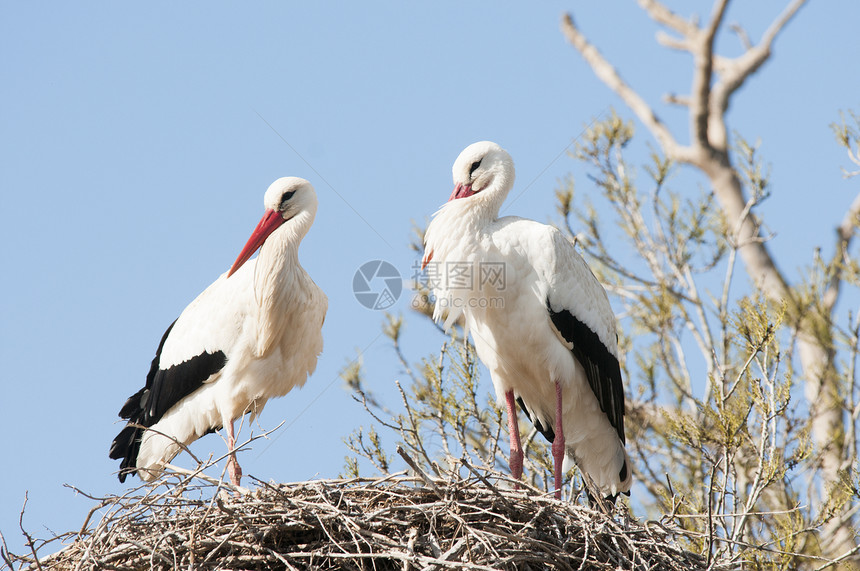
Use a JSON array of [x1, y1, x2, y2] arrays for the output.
[[227, 176, 318, 278]]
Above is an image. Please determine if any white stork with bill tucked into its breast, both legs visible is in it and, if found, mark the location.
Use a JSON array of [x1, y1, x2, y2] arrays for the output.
[[422, 141, 631, 499]]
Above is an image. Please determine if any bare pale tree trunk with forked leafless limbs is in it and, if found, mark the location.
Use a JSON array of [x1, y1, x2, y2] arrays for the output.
[[562, 0, 860, 558]]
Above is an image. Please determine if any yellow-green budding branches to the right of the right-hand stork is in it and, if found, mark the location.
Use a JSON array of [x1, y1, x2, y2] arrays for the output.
[[558, 114, 860, 569]]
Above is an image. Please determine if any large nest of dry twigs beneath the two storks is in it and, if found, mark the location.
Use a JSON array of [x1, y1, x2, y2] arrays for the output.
[[3, 464, 732, 571]]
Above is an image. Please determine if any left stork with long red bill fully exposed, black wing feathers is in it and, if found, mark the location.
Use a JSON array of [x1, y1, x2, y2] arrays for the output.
[[110, 177, 328, 486]]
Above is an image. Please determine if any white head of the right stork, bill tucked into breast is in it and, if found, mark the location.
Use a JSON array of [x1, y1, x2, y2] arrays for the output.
[[448, 141, 514, 206]]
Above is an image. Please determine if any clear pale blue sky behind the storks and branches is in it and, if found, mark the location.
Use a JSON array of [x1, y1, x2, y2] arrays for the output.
[[0, 0, 860, 552]]
